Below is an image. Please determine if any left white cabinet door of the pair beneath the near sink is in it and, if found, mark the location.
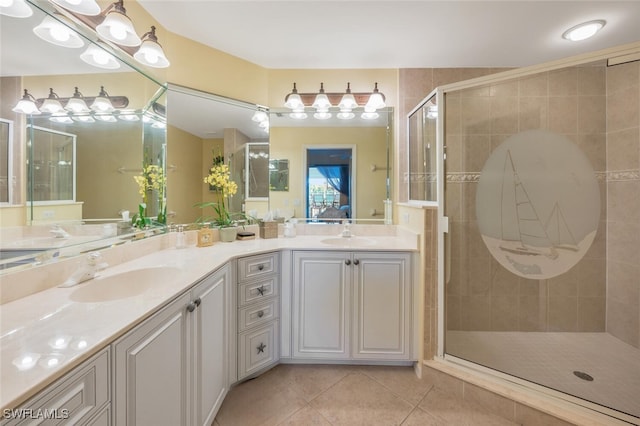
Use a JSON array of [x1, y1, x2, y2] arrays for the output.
[[113, 294, 191, 426]]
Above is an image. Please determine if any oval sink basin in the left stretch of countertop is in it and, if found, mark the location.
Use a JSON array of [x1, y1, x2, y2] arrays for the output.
[[70, 267, 180, 303]]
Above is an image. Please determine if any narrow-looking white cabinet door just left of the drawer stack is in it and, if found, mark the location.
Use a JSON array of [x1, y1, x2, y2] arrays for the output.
[[190, 265, 231, 425]]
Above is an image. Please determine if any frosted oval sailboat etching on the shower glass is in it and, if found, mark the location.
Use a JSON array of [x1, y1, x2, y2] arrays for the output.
[[476, 130, 600, 279]]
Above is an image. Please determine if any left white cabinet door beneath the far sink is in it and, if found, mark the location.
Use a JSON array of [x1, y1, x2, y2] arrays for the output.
[[292, 251, 351, 359]]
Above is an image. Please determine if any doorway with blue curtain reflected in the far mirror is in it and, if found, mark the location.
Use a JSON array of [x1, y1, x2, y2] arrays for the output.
[[305, 147, 355, 221]]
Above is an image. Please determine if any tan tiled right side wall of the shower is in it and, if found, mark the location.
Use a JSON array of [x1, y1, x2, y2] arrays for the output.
[[607, 62, 640, 348]]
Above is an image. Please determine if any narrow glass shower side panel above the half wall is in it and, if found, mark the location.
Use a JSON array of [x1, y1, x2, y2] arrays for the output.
[[407, 92, 438, 202]]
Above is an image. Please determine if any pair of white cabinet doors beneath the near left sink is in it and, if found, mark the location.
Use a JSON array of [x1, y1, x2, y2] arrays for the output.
[[113, 265, 231, 426]]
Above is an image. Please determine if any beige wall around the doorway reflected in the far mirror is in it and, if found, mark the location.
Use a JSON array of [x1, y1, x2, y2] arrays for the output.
[[269, 127, 387, 219]]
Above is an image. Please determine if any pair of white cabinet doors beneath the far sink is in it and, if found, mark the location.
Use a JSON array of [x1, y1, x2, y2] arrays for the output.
[[291, 251, 412, 361]]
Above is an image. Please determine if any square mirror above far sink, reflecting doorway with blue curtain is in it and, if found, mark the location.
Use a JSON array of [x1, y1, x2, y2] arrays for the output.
[[269, 107, 393, 223]]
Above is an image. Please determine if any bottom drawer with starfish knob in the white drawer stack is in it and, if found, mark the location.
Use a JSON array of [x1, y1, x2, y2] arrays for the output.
[[238, 320, 280, 379]]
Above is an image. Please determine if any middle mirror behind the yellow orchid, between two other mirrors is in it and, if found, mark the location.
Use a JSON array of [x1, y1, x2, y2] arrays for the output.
[[166, 84, 269, 228]]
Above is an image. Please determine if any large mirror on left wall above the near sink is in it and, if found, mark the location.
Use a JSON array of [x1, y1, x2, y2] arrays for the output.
[[0, 1, 166, 270]]
